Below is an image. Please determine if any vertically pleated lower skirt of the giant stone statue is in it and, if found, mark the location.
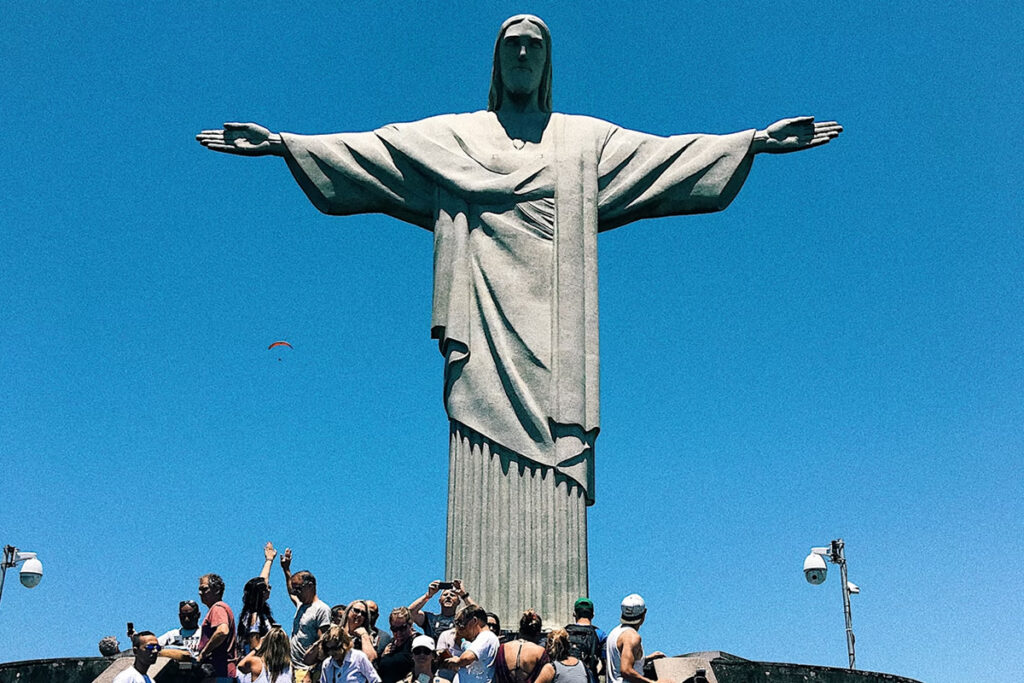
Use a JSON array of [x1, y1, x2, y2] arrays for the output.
[[445, 422, 588, 630]]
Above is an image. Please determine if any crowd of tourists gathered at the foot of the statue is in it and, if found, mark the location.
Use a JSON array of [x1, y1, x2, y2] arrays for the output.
[[104, 543, 666, 683]]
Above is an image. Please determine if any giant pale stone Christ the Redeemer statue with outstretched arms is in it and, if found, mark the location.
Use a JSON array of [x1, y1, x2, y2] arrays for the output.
[[198, 15, 842, 624]]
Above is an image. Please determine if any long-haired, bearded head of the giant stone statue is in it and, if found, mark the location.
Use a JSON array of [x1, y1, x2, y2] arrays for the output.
[[487, 14, 551, 112]]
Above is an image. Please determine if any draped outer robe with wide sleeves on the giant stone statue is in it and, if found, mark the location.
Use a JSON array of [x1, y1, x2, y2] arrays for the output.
[[282, 112, 754, 507]]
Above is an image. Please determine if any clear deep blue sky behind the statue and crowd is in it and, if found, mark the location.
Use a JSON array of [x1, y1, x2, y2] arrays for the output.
[[0, 1, 1024, 683]]
